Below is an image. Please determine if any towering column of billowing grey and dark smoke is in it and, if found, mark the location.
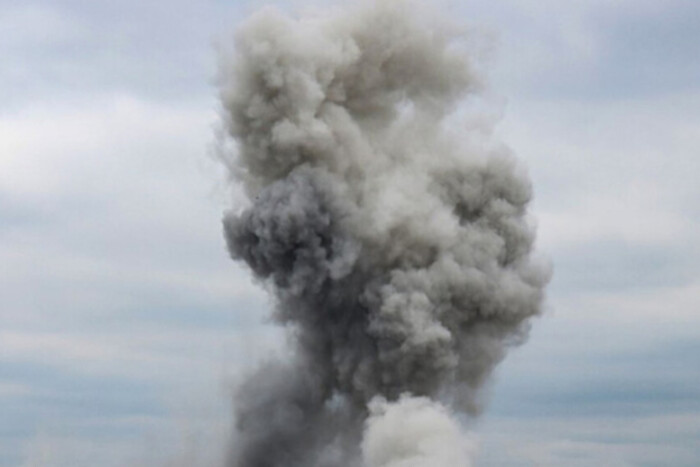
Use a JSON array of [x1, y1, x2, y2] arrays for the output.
[[219, 1, 550, 467]]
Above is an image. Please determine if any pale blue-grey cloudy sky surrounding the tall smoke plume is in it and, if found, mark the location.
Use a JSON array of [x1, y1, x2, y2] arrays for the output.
[[0, 0, 700, 467]]
